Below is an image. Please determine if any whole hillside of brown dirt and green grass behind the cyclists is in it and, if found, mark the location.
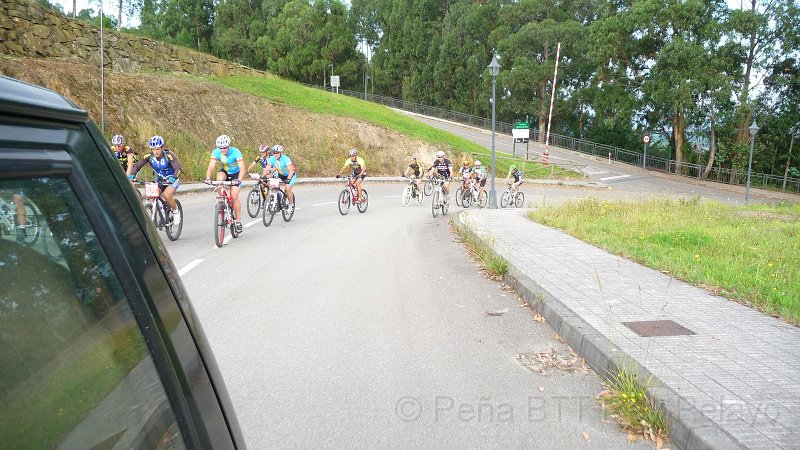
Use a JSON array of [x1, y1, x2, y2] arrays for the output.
[[0, 57, 580, 180]]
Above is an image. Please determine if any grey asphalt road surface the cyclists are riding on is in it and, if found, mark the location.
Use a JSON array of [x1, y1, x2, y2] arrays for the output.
[[165, 184, 650, 448]]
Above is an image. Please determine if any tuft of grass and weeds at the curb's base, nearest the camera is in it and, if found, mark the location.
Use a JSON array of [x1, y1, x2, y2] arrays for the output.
[[600, 369, 669, 448]]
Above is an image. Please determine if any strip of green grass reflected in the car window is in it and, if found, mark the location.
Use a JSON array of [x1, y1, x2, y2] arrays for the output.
[[0, 323, 147, 448]]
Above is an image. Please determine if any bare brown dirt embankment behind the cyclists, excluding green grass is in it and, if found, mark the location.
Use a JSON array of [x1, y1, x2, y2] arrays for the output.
[[0, 57, 436, 180]]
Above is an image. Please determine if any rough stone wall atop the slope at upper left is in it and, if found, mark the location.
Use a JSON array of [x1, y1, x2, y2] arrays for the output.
[[0, 0, 265, 75]]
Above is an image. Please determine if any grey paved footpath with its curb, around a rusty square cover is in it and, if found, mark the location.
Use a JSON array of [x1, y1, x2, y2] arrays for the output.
[[456, 210, 800, 449]]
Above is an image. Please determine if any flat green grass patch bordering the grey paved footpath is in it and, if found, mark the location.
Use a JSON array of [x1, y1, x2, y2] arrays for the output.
[[529, 198, 800, 324]]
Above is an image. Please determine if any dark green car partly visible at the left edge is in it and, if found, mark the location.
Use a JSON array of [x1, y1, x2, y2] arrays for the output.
[[0, 77, 245, 449]]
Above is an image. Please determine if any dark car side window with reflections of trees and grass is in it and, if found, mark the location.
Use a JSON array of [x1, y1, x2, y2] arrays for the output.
[[0, 178, 185, 449]]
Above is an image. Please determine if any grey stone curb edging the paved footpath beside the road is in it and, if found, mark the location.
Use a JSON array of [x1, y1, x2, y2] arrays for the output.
[[453, 212, 746, 450]]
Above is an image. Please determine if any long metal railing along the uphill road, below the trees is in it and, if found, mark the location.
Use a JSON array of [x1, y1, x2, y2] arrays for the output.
[[305, 84, 800, 193]]
